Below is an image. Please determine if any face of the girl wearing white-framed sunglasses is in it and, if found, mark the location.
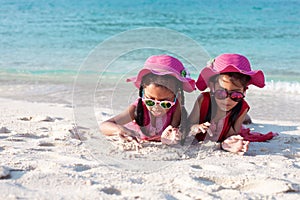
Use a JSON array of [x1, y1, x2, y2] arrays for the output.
[[144, 84, 175, 117]]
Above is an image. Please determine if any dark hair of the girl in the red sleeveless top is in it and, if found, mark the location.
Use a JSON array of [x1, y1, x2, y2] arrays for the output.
[[206, 72, 251, 130]]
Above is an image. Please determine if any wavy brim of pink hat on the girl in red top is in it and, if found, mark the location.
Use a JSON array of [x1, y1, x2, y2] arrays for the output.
[[196, 65, 265, 91]]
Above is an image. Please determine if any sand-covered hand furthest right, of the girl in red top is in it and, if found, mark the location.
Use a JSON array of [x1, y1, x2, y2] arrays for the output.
[[221, 135, 249, 155]]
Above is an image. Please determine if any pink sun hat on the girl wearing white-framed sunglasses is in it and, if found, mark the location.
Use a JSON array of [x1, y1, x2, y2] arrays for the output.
[[126, 55, 196, 92]]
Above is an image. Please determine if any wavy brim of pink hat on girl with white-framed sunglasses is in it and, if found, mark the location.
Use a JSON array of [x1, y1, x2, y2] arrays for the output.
[[126, 65, 195, 92]]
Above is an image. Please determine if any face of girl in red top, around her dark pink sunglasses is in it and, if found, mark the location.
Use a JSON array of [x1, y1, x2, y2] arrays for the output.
[[214, 75, 244, 112]]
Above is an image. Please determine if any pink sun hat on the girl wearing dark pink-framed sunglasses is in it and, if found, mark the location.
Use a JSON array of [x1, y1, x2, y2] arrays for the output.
[[196, 53, 265, 91]]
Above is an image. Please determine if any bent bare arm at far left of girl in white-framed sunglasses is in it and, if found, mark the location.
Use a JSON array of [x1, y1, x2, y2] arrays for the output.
[[100, 105, 135, 137]]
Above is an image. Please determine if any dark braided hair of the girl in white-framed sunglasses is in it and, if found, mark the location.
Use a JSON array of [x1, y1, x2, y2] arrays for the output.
[[135, 74, 188, 137]]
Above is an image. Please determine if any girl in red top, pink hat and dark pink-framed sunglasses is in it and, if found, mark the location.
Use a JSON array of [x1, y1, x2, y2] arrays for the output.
[[189, 54, 265, 155]]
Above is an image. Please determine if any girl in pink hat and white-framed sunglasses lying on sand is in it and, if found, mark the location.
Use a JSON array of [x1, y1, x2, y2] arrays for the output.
[[100, 55, 195, 144]]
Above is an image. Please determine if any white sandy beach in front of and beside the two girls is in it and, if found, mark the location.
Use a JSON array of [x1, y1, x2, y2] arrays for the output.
[[0, 99, 300, 200]]
